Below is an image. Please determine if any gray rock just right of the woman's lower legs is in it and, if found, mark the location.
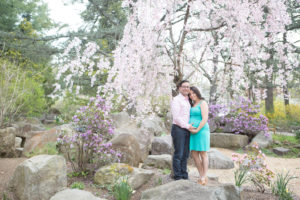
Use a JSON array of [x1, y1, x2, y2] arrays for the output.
[[208, 149, 234, 169]]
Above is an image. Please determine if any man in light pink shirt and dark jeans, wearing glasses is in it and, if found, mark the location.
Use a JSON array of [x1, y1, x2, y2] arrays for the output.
[[171, 80, 191, 180]]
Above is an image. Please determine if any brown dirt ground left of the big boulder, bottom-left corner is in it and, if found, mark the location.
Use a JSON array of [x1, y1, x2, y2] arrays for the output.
[[0, 158, 26, 195]]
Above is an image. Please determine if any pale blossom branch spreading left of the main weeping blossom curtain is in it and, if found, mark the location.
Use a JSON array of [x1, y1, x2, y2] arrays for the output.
[[53, 38, 110, 97]]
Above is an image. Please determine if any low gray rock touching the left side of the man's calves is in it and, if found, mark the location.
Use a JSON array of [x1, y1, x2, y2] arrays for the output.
[[142, 154, 172, 169]]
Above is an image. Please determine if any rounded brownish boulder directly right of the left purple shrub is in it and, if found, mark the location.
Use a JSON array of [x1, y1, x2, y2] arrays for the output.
[[110, 133, 142, 167]]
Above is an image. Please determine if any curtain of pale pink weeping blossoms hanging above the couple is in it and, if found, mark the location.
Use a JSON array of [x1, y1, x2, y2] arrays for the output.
[[102, 0, 291, 113]]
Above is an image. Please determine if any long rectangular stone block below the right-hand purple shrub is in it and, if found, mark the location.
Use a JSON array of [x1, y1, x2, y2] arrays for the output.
[[210, 133, 248, 149]]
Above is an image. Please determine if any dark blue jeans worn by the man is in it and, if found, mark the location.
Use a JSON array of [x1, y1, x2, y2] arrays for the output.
[[171, 124, 190, 180]]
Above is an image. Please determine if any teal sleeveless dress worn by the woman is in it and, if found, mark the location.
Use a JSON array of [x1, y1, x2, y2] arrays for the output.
[[189, 101, 210, 151]]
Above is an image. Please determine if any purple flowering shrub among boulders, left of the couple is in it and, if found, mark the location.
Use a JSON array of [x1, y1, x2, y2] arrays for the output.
[[57, 96, 121, 171]]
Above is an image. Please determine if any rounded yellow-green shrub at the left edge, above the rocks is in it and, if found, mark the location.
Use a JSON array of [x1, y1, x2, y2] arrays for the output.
[[0, 59, 46, 127]]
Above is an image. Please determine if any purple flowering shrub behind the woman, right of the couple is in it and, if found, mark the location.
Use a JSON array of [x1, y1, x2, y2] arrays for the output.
[[209, 98, 268, 136]]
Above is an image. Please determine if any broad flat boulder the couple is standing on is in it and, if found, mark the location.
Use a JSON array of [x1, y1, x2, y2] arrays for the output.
[[141, 180, 241, 200]]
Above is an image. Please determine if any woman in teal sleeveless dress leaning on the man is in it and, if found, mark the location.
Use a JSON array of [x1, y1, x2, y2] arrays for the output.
[[189, 87, 210, 185]]
